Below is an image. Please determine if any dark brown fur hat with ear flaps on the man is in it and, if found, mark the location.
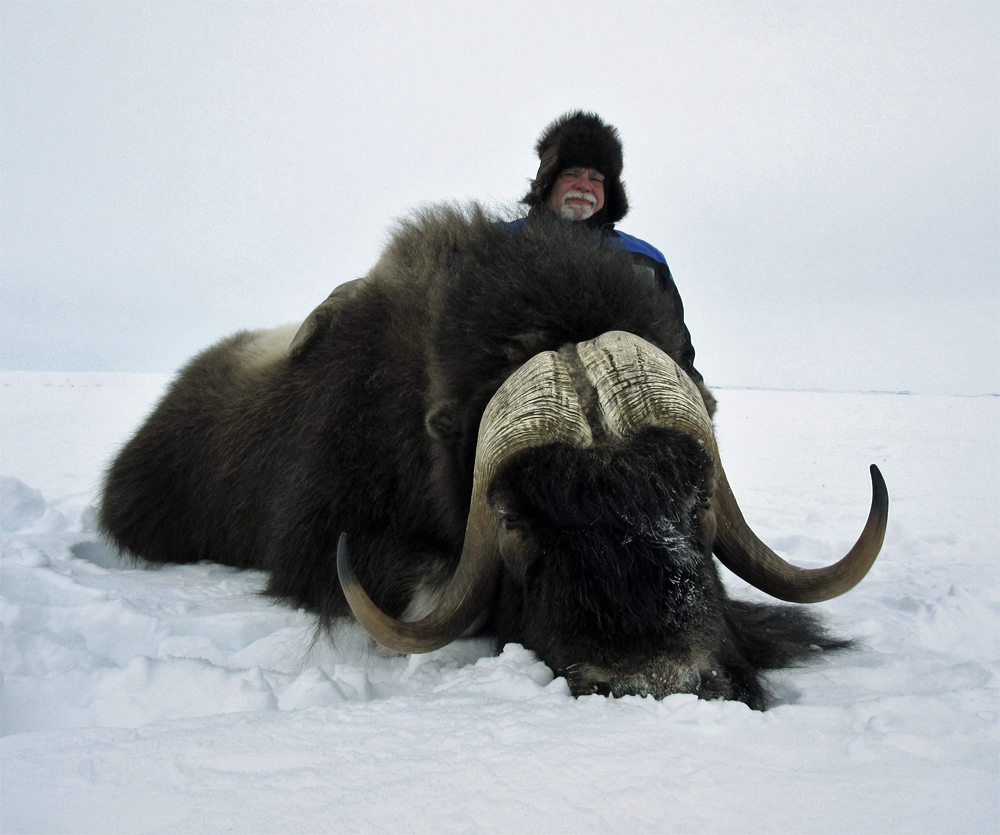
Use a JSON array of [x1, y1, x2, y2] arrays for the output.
[[521, 110, 628, 223]]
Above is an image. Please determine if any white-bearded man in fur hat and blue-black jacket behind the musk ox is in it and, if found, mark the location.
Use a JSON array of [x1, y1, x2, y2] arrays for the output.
[[513, 110, 703, 383]]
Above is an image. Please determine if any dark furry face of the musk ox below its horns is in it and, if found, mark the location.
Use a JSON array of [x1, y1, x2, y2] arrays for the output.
[[490, 429, 724, 696]]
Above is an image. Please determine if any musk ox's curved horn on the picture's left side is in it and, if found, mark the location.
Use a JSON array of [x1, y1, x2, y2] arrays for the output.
[[337, 351, 593, 653]]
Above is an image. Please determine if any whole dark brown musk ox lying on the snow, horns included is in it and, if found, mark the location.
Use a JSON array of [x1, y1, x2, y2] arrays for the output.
[[100, 208, 888, 708]]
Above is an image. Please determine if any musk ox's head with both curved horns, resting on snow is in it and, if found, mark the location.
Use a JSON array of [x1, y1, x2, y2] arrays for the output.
[[338, 332, 888, 707]]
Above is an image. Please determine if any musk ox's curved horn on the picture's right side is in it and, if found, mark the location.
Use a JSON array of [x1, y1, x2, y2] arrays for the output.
[[577, 331, 889, 603]]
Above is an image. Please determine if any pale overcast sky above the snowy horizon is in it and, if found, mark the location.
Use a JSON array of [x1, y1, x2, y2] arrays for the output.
[[0, 0, 1000, 394]]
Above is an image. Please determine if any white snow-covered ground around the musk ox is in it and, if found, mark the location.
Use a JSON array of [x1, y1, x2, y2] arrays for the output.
[[0, 372, 1000, 833]]
